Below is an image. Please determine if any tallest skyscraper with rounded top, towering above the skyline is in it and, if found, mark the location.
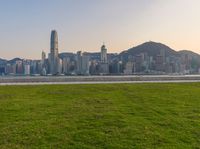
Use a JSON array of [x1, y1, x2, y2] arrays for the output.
[[49, 30, 60, 75]]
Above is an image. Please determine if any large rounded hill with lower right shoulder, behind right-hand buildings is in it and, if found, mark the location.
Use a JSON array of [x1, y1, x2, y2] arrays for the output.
[[118, 41, 200, 70]]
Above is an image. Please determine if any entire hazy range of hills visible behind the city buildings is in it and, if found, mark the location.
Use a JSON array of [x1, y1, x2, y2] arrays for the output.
[[0, 41, 200, 66]]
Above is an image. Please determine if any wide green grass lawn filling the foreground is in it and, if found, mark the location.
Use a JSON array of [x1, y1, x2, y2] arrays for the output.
[[0, 83, 200, 149]]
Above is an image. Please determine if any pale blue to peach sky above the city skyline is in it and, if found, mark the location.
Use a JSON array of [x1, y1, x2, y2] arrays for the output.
[[0, 0, 200, 59]]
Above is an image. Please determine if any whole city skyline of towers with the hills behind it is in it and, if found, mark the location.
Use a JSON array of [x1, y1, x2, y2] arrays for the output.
[[0, 30, 200, 76]]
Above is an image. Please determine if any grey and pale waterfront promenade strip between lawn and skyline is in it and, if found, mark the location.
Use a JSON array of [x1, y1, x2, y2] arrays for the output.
[[0, 75, 200, 85]]
